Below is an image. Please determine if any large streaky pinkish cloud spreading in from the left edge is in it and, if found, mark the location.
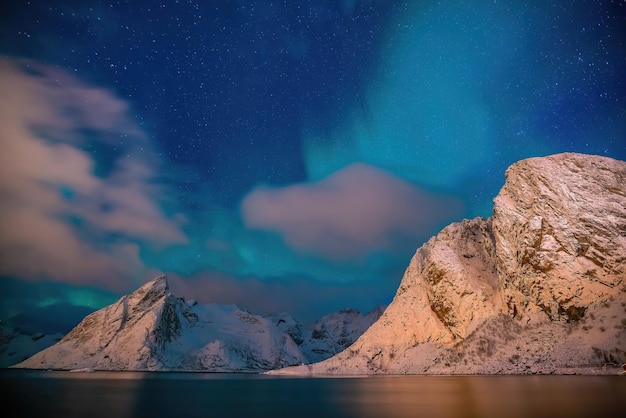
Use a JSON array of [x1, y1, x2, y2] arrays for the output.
[[0, 58, 186, 289]]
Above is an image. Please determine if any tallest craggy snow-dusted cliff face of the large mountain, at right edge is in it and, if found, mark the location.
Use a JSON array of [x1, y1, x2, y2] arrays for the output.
[[493, 153, 626, 321]]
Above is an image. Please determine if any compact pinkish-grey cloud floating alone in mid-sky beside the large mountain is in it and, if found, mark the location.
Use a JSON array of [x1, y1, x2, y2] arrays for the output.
[[241, 163, 462, 259]]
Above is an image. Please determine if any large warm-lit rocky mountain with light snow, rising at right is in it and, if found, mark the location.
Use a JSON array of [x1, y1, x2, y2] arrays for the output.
[[272, 153, 626, 374]]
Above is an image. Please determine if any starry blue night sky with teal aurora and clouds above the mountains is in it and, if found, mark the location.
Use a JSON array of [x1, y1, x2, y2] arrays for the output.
[[0, 0, 626, 332]]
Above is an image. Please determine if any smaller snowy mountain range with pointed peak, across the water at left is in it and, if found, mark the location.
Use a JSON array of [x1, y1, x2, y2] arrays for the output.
[[14, 276, 380, 372]]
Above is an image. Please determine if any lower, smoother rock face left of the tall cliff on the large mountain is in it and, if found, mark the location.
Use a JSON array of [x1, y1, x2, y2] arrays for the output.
[[324, 218, 501, 363]]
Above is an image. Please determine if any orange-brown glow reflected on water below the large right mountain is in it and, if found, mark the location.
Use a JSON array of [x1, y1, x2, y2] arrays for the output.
[[348, 376, 626, 417]]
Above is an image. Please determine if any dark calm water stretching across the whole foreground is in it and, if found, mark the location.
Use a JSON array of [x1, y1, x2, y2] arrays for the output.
[[0, 370, 626, 418]]
